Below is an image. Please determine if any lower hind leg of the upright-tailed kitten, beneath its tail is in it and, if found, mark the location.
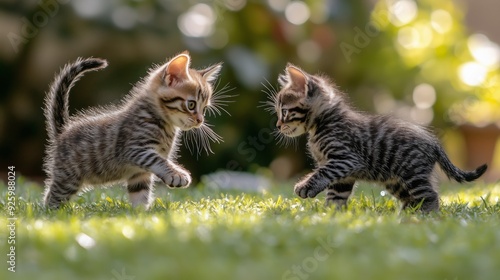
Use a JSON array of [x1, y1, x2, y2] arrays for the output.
[[44, 178, 80, 209]]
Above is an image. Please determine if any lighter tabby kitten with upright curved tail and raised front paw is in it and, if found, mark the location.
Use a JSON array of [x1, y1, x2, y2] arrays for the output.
[[45, 52, 221, 208]]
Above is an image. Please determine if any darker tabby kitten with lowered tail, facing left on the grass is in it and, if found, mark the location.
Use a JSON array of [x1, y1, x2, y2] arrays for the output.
[[269, 64, 487, 212]]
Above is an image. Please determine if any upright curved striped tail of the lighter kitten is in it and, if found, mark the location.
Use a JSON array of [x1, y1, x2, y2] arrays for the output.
[[44, 58, 108, 140]]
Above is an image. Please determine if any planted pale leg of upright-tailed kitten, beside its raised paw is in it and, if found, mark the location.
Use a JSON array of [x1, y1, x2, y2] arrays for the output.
[[127, 173, 153, 209]]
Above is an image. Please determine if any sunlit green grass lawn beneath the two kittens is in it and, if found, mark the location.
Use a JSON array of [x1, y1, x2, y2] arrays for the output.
[[0, 179, 500, 280]]
